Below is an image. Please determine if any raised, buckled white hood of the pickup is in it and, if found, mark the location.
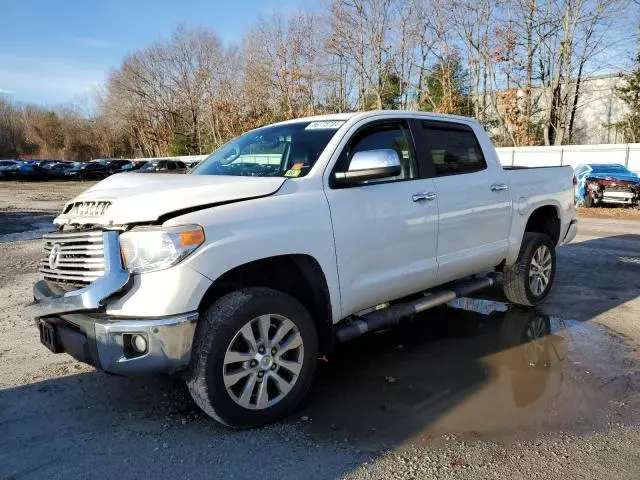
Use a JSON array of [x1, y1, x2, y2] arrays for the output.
[[54, 172, 286, 225]]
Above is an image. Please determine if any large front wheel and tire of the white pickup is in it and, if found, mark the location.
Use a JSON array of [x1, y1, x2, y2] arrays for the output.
[[187, 288, 318, 428]]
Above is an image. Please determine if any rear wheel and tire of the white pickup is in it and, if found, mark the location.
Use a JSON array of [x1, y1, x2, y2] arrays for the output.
[[503, 232, 556, 307]]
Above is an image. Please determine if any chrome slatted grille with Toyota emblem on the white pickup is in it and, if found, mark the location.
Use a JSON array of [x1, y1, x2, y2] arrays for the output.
[[40, 230, 104, 285]]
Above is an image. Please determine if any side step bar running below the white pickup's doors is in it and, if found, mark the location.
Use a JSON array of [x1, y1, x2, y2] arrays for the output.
[[336, 273, 501, 342]]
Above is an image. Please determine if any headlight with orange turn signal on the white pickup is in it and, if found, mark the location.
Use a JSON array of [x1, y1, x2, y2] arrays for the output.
[[120, 225, 204, 273]]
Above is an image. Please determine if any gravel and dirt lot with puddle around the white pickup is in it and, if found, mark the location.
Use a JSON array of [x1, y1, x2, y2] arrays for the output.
[[0, 182, 640, 480]]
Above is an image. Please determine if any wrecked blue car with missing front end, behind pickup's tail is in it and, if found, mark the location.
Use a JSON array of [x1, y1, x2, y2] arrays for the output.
[[573, 163, 640, 208]]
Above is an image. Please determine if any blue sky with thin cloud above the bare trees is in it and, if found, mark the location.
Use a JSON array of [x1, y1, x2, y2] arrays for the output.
[[0, 0, 304, 105]]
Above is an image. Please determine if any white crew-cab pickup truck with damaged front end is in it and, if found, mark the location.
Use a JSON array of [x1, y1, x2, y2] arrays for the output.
[[30, 111, 577, 427]]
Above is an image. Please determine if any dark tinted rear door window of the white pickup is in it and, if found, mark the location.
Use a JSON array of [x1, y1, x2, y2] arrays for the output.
[[423, 121, 487, 177]]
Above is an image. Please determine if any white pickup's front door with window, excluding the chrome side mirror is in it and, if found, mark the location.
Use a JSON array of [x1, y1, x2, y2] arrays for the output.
[[325, 120, 438, 316]]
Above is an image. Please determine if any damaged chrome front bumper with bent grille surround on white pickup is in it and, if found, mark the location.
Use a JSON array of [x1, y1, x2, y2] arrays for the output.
[[27, 232, 198, 375]]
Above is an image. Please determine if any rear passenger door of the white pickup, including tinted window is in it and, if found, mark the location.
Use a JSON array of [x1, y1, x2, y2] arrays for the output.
[[422, 120, 511, 283]]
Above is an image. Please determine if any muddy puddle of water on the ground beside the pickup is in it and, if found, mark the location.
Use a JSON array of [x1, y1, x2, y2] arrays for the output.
[[300, 299, 640, 448]]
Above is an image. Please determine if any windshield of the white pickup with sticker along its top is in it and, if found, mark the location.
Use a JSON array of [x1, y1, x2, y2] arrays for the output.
[[189, 120, 344, 177]]
